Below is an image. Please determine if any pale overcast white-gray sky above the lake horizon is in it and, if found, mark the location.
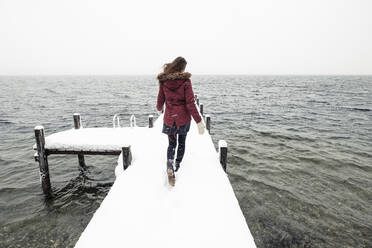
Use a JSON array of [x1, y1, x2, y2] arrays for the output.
[[0, 0, 372, 75]]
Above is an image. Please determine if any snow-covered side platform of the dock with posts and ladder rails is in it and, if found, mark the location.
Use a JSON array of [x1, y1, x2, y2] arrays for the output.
[[33, 113, 158, 197]]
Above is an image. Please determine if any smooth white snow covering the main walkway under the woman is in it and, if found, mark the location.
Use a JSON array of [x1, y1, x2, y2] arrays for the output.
[[75, 116, 256, 248]]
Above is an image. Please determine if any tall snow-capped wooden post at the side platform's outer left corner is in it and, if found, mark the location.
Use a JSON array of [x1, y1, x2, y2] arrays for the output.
[[35, 126, 52, 196]]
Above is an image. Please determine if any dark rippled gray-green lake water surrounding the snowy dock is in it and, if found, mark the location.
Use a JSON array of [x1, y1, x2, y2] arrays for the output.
[[0, 76, 372, 248]]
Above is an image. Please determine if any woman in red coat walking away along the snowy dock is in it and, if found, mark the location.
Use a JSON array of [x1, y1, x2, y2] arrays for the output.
[[156, 57, 205, 186]]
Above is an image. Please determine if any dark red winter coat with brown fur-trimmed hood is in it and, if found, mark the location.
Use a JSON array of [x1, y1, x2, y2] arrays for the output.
[[156, 72, 201, 127]]
